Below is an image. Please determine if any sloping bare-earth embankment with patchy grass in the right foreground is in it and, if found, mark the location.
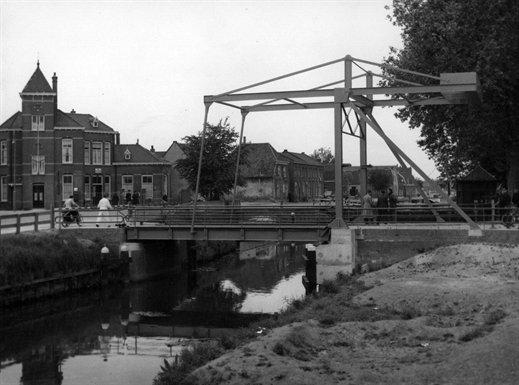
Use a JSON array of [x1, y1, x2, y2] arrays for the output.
[[188, 244, 519, 385]]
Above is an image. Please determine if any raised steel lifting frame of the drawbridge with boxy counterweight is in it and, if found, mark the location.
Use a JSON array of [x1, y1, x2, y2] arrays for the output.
[[196, 55, 481, 231]]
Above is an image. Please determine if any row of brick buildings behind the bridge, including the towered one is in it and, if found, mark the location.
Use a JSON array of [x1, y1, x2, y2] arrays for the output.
[[0, 63, 422, 210]]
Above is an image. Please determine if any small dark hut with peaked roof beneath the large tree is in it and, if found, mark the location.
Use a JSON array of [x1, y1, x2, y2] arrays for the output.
[[455, 165, 497, 205]]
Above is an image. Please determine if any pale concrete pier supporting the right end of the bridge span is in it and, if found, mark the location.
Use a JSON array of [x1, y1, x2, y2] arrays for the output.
[[316, 228, 357, 284]]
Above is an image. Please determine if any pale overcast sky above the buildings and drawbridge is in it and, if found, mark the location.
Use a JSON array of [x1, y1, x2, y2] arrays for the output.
[[0, 0, 438, 177]]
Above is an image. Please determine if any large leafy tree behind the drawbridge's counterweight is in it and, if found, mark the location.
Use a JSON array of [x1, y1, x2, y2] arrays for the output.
[[385, 0, 519, 185]]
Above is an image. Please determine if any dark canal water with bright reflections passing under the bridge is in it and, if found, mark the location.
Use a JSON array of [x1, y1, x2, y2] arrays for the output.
[[0, 244, 305, 385]]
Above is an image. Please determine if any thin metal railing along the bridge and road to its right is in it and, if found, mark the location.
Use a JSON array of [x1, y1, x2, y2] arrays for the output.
[[127, 204, 511, 226]]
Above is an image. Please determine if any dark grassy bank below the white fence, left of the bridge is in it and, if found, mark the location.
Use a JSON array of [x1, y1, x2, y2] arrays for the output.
[[0, 231, 117, 287]]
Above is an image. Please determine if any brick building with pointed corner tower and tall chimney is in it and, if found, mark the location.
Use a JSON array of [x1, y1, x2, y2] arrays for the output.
[[0, 63, 169, 209]]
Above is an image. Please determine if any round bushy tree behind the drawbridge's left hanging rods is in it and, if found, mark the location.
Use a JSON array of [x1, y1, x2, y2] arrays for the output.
[[175, 119, 245, 200]]
